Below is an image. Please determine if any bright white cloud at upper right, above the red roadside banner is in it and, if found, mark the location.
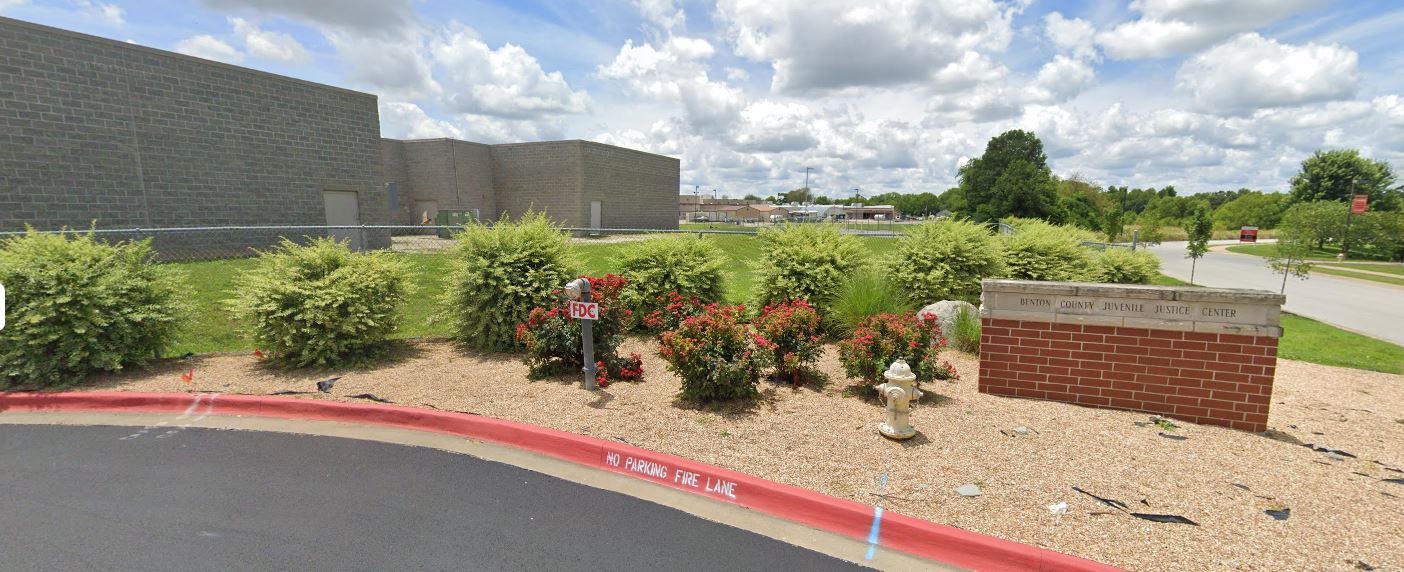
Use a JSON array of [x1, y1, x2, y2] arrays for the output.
[[1175, 34, 1359, 114]]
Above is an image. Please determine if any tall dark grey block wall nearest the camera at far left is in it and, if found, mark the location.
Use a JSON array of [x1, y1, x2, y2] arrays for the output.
[[0, 18, 388, 230]]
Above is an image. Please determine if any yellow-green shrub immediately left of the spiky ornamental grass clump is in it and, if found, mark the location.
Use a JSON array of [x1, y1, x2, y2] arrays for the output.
[[758, 223, 868, 316]]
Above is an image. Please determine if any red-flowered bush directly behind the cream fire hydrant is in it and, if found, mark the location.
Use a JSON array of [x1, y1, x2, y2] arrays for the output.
[[838, 313, 960, 385]]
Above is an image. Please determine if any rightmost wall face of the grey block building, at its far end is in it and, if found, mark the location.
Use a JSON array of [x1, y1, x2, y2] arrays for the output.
[[581, 142, 680, 229]]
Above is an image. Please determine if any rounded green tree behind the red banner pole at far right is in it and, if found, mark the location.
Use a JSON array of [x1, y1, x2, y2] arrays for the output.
[[1292, 149, 1404, 211]]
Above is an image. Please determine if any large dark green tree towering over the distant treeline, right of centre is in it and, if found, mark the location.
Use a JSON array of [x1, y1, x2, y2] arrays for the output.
[[960, 129, 1063, 222]]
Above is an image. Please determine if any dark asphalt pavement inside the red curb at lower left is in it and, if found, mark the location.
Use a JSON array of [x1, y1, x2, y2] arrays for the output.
[[0, 424, 856, 571]]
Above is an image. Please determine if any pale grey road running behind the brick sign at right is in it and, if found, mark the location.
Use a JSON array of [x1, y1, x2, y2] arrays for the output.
[[1151, 240, 1404, 346]]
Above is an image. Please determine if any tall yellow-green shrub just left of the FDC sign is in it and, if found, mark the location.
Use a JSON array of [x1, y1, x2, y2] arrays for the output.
[[441, 212, 577, 351]]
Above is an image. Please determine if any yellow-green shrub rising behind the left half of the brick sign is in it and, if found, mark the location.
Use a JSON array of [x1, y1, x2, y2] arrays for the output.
[[1001, 219, 1097, 281]]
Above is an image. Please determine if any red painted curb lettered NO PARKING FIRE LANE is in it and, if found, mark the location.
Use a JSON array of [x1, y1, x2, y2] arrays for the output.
[[0, 392, 1118, 572]]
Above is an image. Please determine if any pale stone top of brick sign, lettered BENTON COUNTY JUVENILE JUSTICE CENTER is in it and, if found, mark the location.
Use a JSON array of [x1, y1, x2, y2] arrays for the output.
[[980, 280, 1286, 337]]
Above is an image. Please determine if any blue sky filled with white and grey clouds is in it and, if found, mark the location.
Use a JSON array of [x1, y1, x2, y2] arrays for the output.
[[0, 0, 1404, 197]]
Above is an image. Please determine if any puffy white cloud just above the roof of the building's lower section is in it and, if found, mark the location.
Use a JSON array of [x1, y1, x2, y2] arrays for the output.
[[430, 27, 590, 119]]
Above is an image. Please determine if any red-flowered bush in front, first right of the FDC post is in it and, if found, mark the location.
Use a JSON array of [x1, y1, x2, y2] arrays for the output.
[[658, 304, 767, 401]]
